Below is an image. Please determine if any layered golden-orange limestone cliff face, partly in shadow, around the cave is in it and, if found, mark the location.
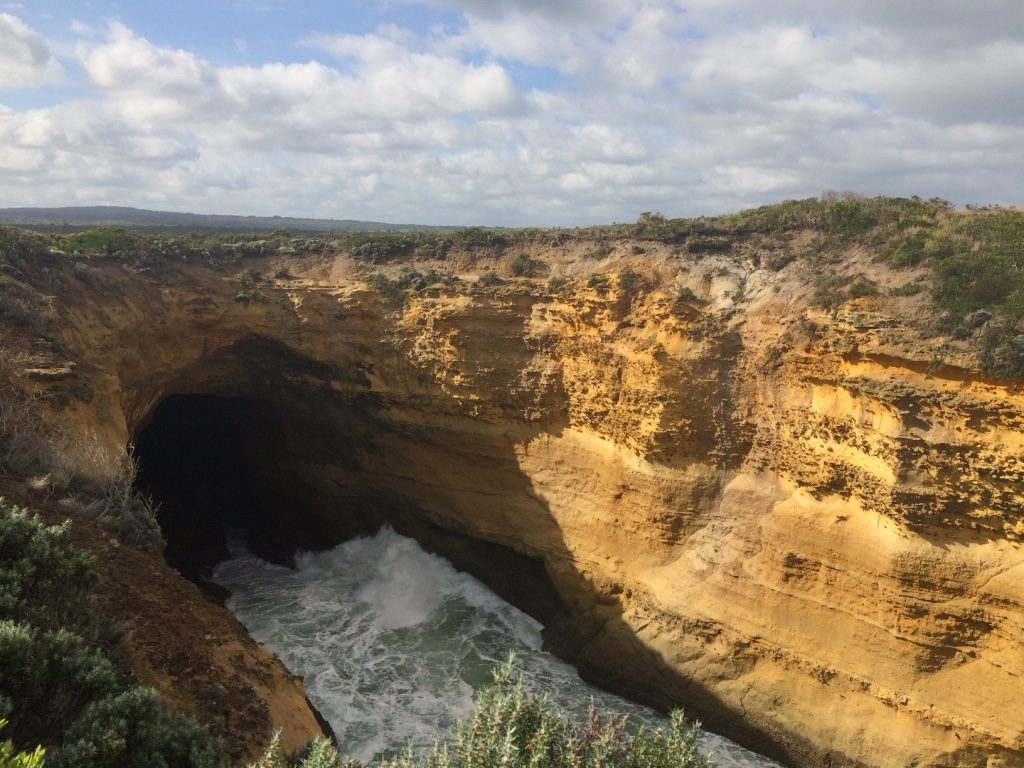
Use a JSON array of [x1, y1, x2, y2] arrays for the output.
[[24, 233, 1024, 766]]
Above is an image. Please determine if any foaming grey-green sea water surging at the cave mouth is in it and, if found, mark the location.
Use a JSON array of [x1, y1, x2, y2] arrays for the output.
[[214, 528, 778, 768]]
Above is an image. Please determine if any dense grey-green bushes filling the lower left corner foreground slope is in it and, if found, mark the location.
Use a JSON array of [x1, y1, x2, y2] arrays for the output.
[[0, 500, 225, 768]]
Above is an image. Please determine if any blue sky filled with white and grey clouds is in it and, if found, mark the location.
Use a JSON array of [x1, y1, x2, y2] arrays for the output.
[[0, 0, 1024, 226]]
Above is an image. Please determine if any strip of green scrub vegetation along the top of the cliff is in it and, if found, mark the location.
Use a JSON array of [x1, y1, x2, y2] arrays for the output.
[[0, 193, 1024, 377]]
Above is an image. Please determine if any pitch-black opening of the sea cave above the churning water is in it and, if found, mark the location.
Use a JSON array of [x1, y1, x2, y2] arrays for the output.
[[135, 394, 337, 581]]
